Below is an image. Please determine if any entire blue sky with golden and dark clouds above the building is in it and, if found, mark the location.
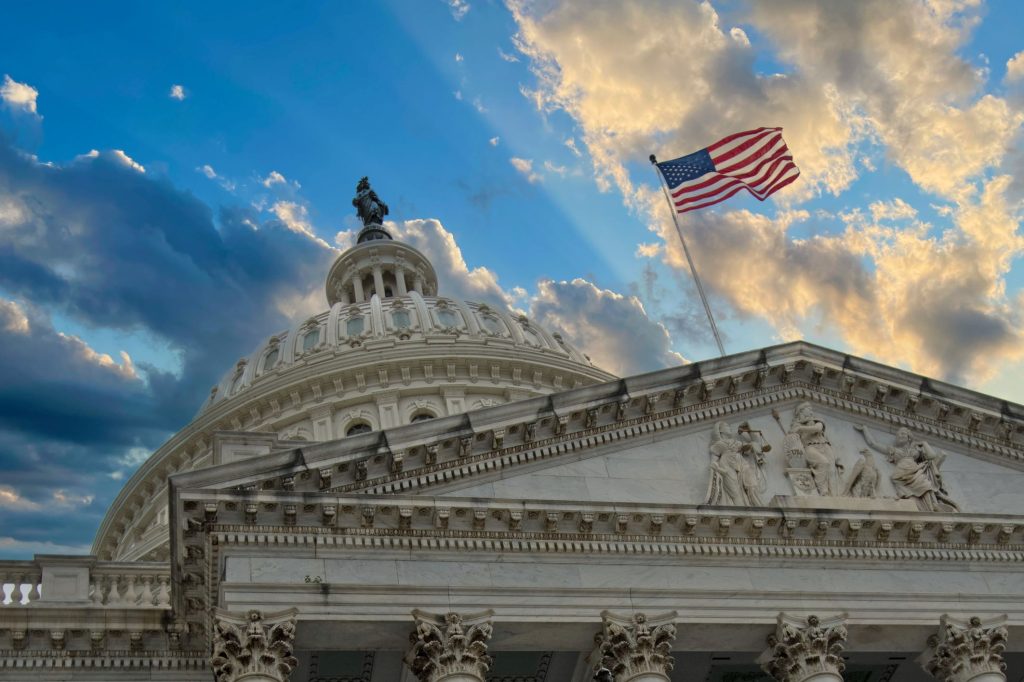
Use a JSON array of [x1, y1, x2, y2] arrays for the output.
[[0, 0, 1024, 556]]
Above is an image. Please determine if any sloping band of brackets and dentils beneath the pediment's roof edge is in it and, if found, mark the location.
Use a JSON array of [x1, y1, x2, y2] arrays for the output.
[[197, 379, 1024, 503]]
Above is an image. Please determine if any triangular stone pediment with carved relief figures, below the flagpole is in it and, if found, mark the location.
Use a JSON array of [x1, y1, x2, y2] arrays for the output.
[[174, 343, 1024, 515]]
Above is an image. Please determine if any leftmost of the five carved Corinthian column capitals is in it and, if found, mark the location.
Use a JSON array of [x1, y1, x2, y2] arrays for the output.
[[210, 608, 298, 682]]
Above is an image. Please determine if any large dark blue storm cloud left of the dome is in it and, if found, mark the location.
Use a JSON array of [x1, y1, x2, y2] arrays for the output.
[[0, 138, 333, 553]]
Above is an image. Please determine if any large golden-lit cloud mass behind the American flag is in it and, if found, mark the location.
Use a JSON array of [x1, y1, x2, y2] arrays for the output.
[[511, 0, 1024, 382]]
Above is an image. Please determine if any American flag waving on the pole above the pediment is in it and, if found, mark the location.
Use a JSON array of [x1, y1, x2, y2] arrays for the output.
[[657, 128, 800, 213]]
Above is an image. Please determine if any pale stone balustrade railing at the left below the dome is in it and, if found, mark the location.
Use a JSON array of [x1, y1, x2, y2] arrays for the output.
[[0, 554, 171, 609]]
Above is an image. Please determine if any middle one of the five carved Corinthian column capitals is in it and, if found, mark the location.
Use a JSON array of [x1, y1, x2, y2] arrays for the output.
[[594, 611, 676, 682]]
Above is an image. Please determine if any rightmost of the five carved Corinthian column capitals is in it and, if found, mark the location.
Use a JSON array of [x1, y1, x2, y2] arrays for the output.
[[919, 615, 1007, 682]]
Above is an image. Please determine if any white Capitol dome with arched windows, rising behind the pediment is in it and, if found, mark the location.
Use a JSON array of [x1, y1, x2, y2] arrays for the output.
[[92, 183, 615, 560]]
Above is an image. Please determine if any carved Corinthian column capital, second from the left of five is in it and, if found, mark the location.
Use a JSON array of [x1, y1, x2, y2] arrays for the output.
[[406, 610, 494, 682]]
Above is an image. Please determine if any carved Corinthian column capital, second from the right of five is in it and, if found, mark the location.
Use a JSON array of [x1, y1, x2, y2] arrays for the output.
[[758, 613, 846, 682]]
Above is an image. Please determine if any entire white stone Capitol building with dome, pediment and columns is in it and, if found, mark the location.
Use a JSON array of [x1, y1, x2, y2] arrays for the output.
[[0, 178, 1024, 682]]
